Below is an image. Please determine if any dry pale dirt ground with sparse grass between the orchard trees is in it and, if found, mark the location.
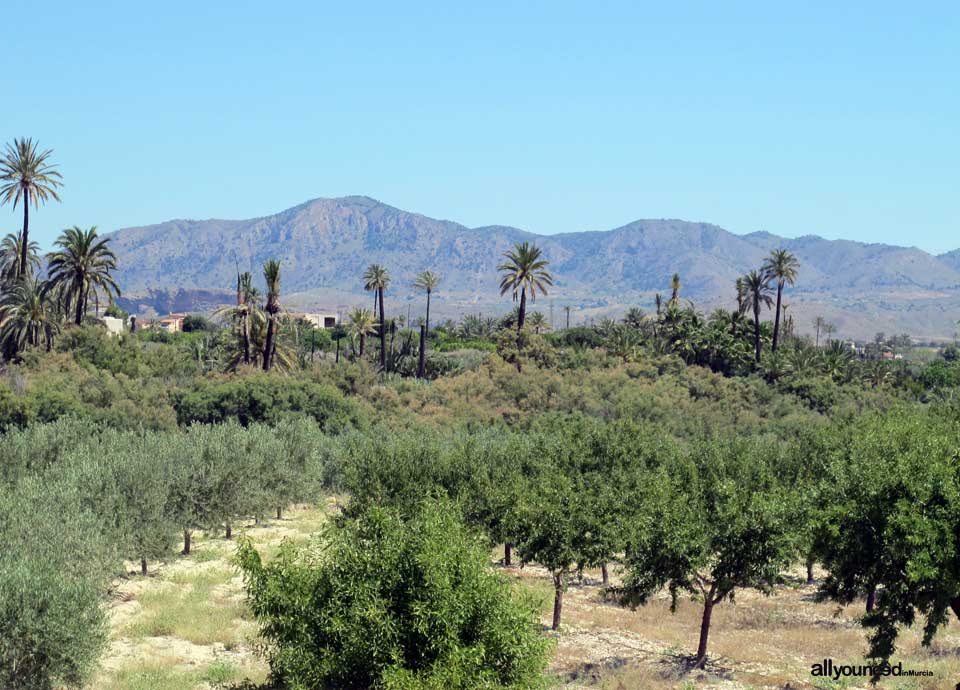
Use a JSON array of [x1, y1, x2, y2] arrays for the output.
[[92, 501, 960, 690]]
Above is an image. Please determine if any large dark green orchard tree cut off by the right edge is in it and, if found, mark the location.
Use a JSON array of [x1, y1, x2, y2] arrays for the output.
[[818, 409, 960, 660]]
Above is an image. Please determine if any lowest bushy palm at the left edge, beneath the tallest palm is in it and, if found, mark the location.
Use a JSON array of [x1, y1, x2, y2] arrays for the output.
[[0, 277, 60, 352]]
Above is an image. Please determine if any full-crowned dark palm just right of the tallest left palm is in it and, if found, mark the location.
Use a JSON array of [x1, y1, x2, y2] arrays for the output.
[[47, 225, 120, 326]]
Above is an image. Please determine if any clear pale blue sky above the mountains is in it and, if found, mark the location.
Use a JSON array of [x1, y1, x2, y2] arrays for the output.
[[0, 0, 960, 252]]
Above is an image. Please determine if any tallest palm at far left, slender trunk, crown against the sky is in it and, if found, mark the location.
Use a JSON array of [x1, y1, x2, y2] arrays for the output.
[[0, 139, 63, 278]]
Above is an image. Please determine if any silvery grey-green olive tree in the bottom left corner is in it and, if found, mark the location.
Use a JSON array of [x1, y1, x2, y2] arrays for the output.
[[0, 476, 112, 690]]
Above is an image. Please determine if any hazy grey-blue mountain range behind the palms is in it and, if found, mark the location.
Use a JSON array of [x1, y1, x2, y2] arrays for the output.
[[110, 196, 960, 339]]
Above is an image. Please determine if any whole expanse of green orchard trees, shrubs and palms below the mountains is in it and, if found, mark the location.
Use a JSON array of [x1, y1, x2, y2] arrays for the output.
[[0, 137, 960, 690]]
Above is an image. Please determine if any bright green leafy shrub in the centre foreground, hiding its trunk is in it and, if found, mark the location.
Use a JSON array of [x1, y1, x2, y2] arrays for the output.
[[238, 502, 548, 690]]
